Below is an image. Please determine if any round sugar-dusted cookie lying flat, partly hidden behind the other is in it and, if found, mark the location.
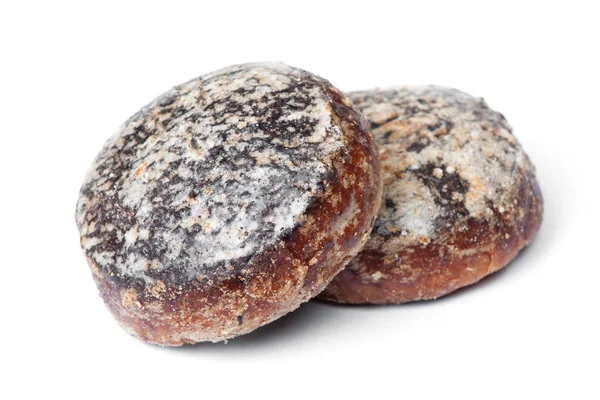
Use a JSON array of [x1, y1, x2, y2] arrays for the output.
[[320, 86, 542, 304]]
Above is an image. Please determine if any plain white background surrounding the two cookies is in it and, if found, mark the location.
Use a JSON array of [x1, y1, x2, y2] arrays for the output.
[[0, 0, 600, 400]]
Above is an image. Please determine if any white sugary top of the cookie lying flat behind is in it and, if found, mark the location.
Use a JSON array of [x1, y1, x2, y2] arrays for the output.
[[349, 86, 533, 246]]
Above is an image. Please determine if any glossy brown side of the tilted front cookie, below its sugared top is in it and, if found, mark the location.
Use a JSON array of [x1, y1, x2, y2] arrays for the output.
[[78, 64, 381, 346]]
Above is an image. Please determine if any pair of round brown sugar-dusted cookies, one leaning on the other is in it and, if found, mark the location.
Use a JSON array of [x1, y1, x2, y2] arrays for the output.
[[76, 63, 542, 345]]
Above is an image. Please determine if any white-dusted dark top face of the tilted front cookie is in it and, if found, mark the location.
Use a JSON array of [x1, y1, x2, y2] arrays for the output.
[[76, 63, 343, 280]]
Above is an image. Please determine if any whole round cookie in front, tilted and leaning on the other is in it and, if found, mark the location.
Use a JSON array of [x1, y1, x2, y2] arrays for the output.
[[76, 63, 381, 345]]
